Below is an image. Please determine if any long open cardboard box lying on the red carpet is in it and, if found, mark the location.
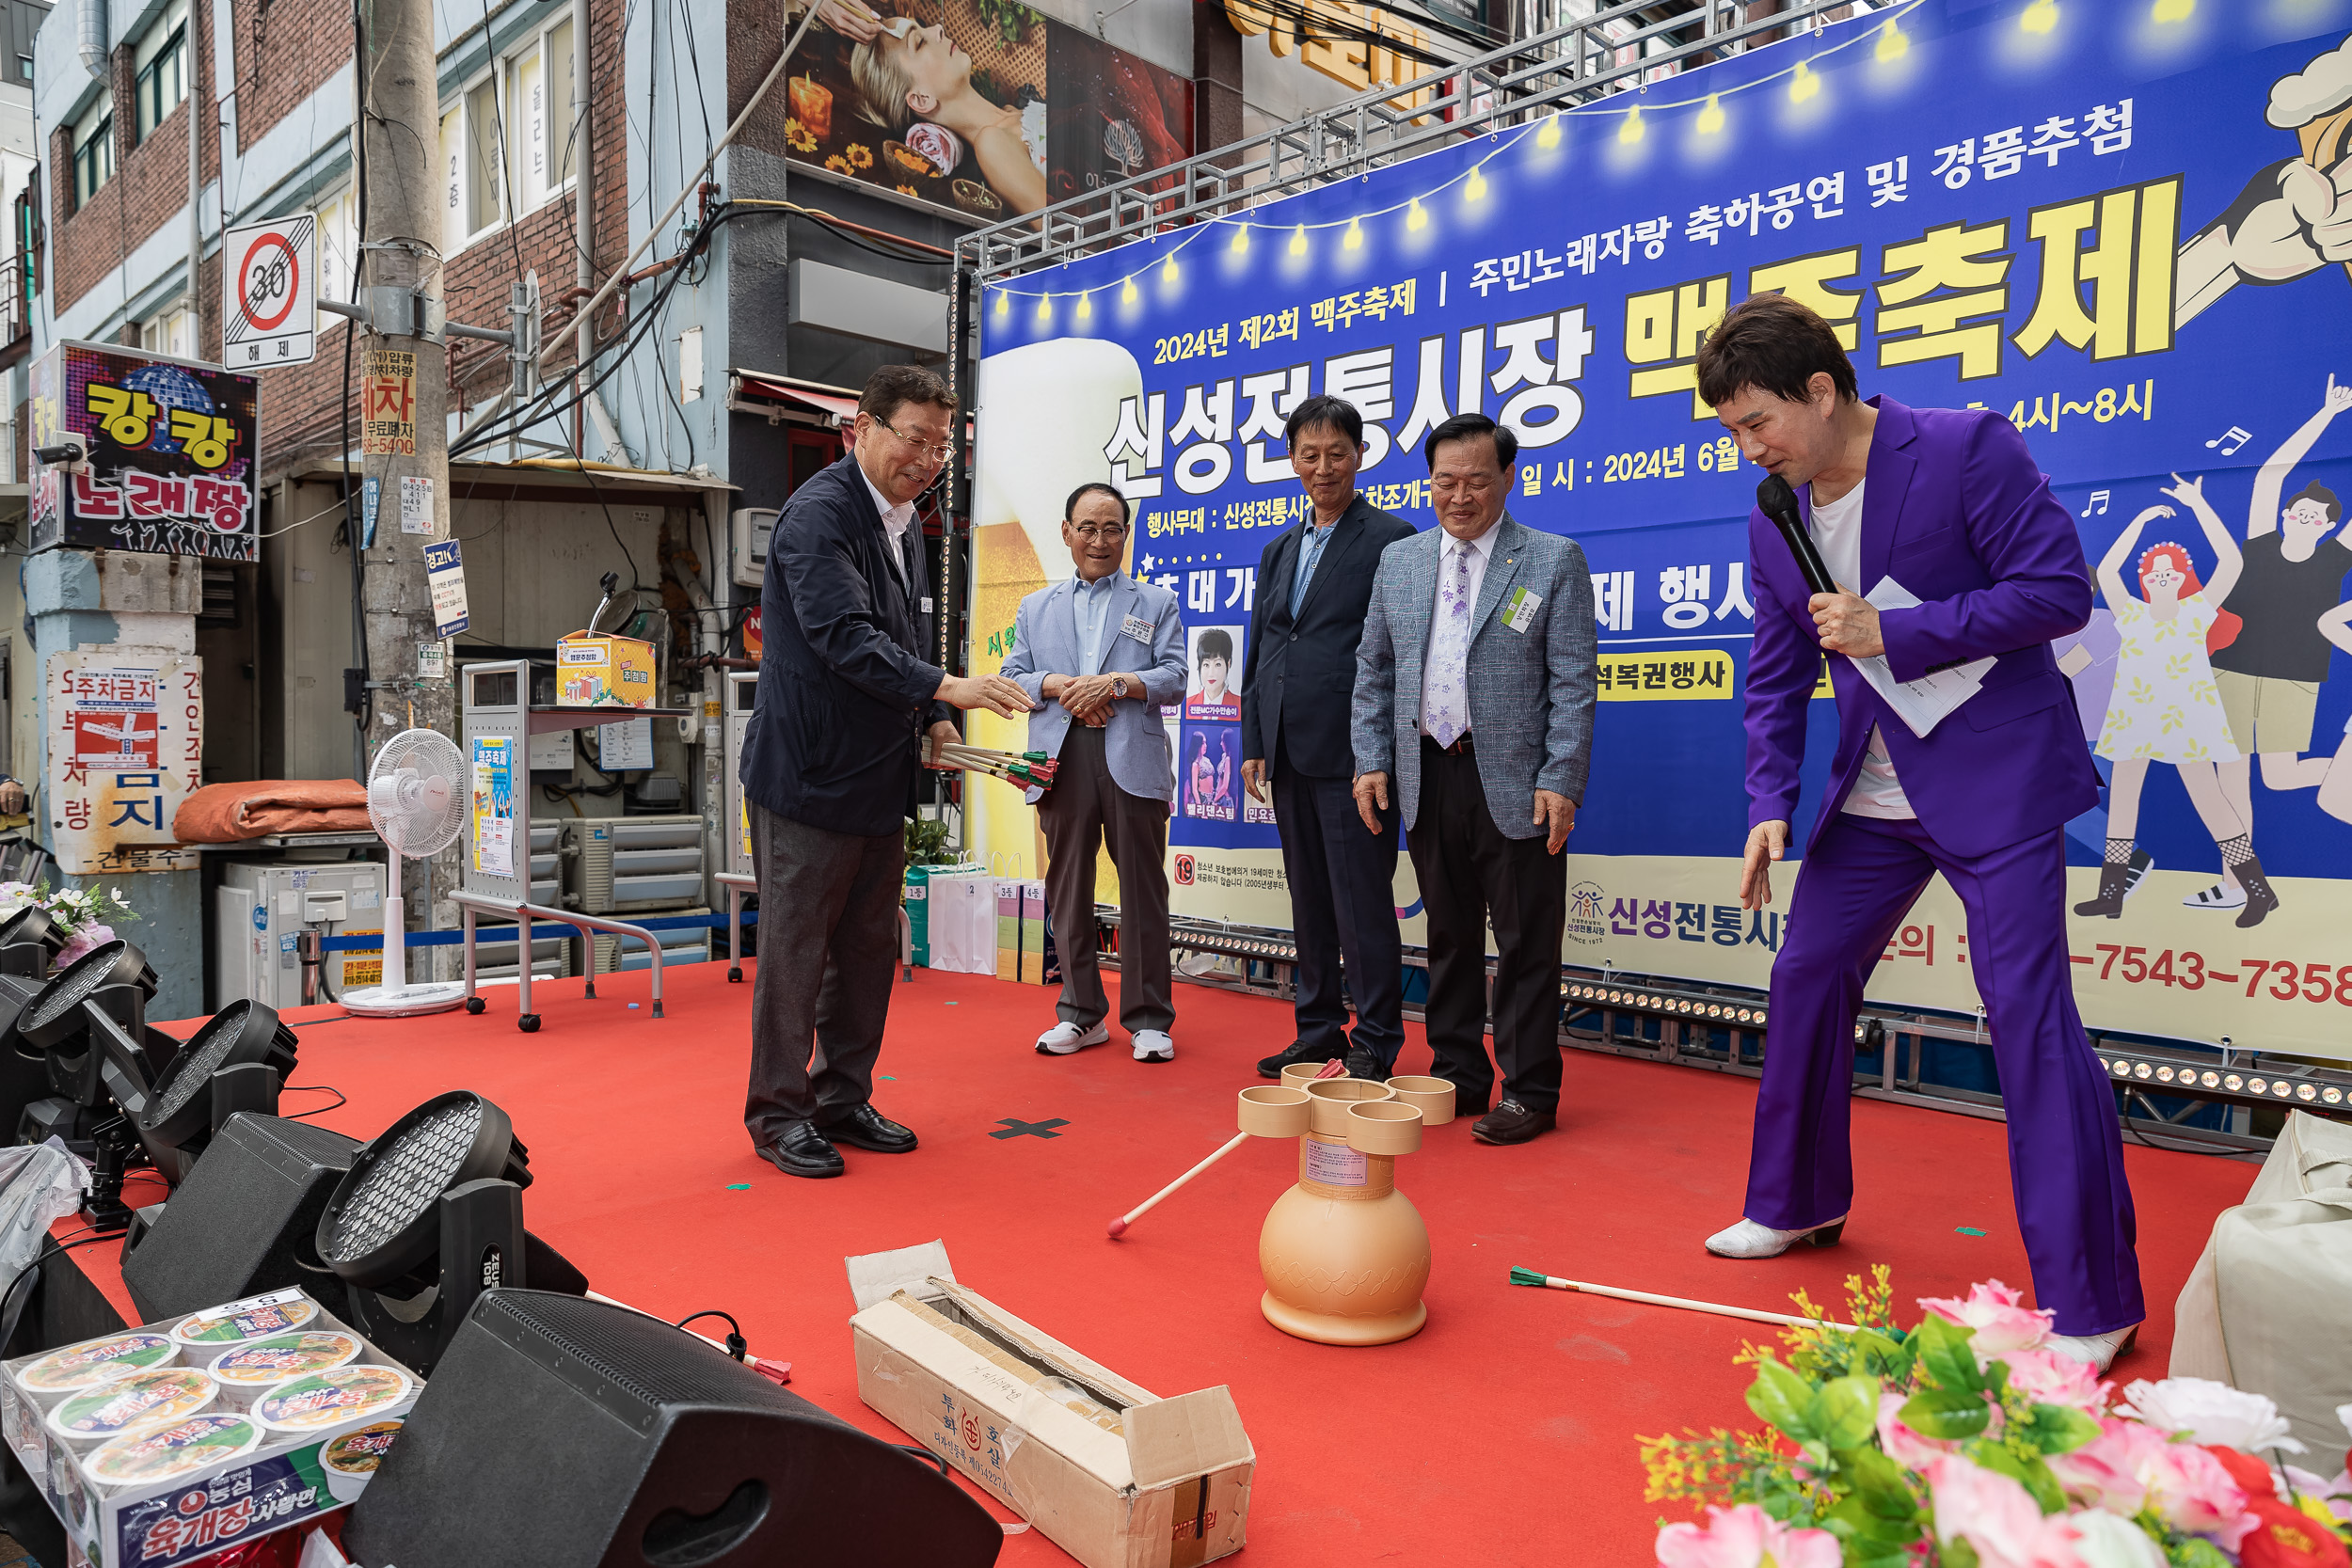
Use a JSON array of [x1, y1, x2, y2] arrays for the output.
[[850, 1242, 1259, 1568]]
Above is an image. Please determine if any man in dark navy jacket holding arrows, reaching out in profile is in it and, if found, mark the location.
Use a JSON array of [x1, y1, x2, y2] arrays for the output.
[[743, 364, 1030, 1176]]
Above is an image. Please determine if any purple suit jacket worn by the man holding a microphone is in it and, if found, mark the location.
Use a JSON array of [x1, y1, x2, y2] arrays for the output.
[[1748, 397, 2098, 856]]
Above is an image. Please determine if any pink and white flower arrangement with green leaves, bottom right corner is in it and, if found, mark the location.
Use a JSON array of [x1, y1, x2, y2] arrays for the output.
[[1642, 1265, 2352, 1568]]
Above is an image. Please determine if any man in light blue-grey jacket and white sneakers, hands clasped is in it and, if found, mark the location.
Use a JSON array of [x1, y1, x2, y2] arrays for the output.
[[1000, 484, 1185, 1063]]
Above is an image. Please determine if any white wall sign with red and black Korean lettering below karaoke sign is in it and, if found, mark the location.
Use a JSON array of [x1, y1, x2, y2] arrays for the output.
[[47, 646, 205, 877]]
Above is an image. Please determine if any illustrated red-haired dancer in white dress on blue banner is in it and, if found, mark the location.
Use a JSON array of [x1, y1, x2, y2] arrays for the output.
[[2074, 491, 2280, 927]]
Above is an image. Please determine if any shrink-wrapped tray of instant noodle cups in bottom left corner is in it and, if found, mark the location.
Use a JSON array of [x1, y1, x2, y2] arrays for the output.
[[0, 1289, 423, 1568]]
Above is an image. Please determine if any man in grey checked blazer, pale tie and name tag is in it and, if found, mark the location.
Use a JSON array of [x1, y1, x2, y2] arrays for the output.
[[1355, 414, 1597, 1143]]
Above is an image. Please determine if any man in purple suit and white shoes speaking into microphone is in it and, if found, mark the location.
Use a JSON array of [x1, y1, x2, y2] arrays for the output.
[[1698, 293, 2145, 1370]]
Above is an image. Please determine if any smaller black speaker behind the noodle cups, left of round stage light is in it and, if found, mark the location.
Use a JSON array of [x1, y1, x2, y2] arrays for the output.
[[122, 1112, 360, 1323]]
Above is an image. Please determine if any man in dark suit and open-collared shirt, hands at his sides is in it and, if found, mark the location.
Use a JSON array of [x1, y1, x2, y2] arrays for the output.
[[1242, 397, 1414, 1079]]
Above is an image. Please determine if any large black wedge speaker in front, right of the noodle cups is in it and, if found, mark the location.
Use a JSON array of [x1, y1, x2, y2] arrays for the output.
[[343, 1291, 1005, 1568]]
